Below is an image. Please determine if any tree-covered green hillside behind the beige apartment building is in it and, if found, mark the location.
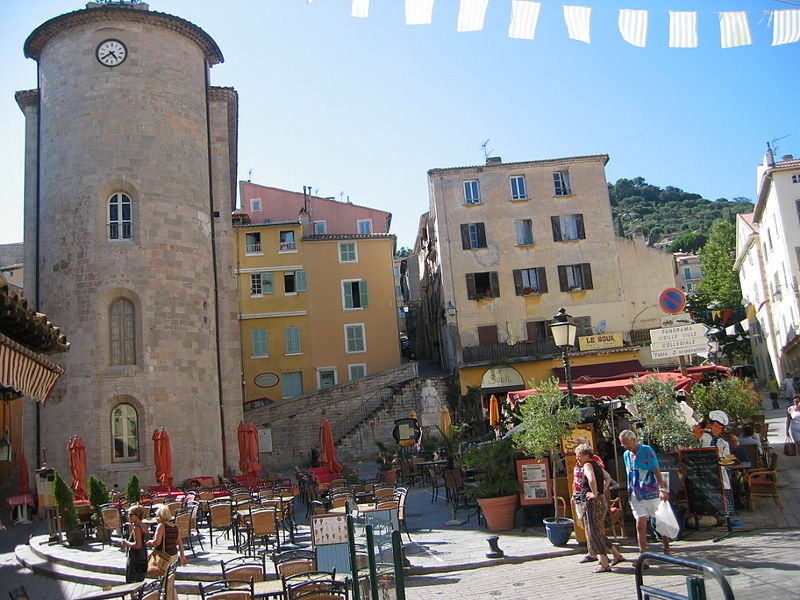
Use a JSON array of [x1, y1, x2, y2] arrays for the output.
[[608, 177, 754, 247]]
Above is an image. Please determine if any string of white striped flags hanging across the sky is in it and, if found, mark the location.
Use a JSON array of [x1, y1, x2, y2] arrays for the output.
[[332, 0, 800, 48]]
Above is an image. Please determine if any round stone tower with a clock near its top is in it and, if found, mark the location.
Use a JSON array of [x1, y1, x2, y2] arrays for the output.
[[17, 2, 242, 486]]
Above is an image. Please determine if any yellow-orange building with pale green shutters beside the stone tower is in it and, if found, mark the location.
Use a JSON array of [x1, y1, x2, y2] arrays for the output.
[[235, 215, 400, 404]]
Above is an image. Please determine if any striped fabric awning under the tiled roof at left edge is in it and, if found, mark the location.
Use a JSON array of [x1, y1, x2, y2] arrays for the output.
[[0, 333, 64, 402]]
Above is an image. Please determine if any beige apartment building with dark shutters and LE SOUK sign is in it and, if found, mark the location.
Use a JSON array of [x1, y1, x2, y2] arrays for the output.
[[417, 154, 674, 392]]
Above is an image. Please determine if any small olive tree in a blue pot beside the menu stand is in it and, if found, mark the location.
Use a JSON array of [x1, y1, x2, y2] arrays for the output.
[[513, 377, 580, 546]]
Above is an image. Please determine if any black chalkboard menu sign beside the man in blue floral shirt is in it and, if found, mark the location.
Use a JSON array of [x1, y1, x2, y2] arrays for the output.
[[679, 448, 725, 516]]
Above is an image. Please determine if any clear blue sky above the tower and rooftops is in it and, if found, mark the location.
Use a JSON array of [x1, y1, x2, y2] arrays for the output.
[[0, 0, 800, 246]]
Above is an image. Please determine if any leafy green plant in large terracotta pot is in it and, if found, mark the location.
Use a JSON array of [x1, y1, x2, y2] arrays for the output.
[[462, 438, 519, 531]]
